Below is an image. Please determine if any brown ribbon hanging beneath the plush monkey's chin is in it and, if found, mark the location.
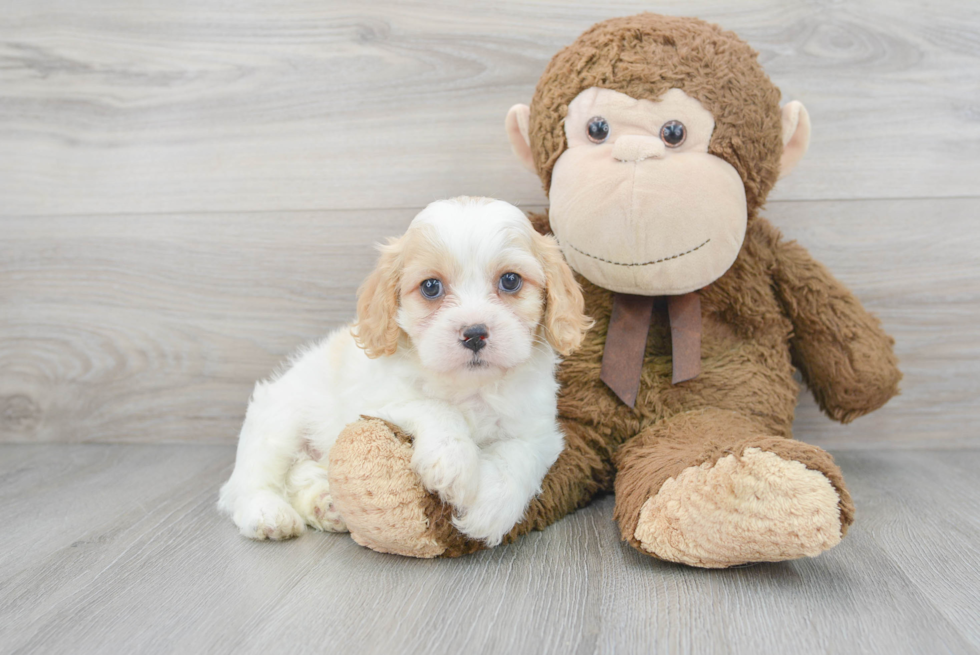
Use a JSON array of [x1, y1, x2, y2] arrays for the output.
[[599, 291, 701, 407]]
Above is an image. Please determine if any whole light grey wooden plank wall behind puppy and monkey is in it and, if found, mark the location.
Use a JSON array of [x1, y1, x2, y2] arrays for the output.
[[0, 0, 980, 448]]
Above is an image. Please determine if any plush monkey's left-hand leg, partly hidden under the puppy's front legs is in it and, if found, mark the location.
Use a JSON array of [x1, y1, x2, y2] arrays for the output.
[[329, 419, 613, 557]]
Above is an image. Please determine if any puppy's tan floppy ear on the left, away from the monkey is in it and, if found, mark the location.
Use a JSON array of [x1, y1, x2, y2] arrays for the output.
[[351, 239, 404, 358]]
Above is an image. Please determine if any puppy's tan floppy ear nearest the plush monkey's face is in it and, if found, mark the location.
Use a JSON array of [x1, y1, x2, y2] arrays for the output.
[[531, 232, 594, 355]]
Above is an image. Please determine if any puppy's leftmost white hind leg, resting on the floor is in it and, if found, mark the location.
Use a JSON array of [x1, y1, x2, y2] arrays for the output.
[[218, 383, 305, 540]]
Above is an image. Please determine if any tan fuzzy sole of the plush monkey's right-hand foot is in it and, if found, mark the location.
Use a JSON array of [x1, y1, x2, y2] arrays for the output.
[[634, 448, 841, 568]]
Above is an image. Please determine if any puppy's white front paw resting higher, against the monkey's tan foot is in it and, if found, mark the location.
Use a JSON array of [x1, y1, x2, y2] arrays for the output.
[[412, 437, 480, 507]]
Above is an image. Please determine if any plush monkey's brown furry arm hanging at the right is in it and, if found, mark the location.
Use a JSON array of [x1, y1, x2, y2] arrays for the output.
[[773, 233, 902, 423]]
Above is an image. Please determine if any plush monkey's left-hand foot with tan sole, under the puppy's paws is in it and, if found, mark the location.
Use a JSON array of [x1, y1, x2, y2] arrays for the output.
[[329, 418, 483, 558]]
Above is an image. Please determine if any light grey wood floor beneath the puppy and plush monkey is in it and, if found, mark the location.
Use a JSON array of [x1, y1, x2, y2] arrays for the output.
[[0, 444, 980, 655]]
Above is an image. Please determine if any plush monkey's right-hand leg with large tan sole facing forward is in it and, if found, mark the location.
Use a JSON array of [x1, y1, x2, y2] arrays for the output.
[[616, 409, 854, 568]]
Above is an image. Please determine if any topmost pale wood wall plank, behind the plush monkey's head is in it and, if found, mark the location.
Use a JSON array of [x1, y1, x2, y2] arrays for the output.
[[0, 0, 980, 215]]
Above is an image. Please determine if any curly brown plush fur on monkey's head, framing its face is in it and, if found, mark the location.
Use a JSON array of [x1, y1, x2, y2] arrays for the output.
[[529, 14, 782, 208]]
